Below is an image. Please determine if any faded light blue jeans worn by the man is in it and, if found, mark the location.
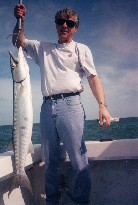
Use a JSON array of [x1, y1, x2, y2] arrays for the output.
[[40, 95, 91, 205]]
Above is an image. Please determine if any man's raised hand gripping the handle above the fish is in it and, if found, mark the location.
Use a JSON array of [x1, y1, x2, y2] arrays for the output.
[[14, 4, 26, 20]]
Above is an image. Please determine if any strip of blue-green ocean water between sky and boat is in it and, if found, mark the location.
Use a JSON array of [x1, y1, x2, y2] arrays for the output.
[[0, 117, 138, 153]]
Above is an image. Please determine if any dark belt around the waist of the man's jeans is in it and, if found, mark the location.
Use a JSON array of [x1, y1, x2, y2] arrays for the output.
[[43, 92, 80, 101]]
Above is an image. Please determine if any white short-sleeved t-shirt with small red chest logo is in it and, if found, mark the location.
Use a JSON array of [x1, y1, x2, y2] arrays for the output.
[[25, 39, 97, 96]]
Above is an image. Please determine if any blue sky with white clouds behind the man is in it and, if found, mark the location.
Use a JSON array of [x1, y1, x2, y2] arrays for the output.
[[0, 0, 138, 125]]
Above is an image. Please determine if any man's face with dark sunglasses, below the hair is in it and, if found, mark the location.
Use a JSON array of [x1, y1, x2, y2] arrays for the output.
[[56, 17, 78, 43]]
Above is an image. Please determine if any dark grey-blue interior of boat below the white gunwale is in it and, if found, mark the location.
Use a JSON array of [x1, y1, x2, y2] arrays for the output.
[[0, 159, 138, 205]]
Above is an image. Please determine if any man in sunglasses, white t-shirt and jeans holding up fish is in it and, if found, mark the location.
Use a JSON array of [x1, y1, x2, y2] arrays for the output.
[[13, 4, 110, 205]]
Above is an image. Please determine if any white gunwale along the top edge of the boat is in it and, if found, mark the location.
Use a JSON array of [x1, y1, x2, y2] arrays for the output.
[[0, 139, 138, 181]]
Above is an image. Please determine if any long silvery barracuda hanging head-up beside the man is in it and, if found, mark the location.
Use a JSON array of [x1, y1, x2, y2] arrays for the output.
[[8, 47, 33, 199]]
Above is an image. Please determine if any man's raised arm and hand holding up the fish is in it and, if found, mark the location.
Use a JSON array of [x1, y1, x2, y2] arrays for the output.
[[12, 4, 26, 48]]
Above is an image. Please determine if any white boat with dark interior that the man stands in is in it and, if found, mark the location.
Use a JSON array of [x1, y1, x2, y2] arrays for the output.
[[0, 139, 138, 205]]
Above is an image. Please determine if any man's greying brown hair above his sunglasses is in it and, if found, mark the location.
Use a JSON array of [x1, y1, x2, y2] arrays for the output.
[[55, 8, 79, 27]]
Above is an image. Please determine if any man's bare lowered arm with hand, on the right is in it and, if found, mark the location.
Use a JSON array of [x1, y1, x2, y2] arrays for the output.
[[88, 75, 110, 127]]
